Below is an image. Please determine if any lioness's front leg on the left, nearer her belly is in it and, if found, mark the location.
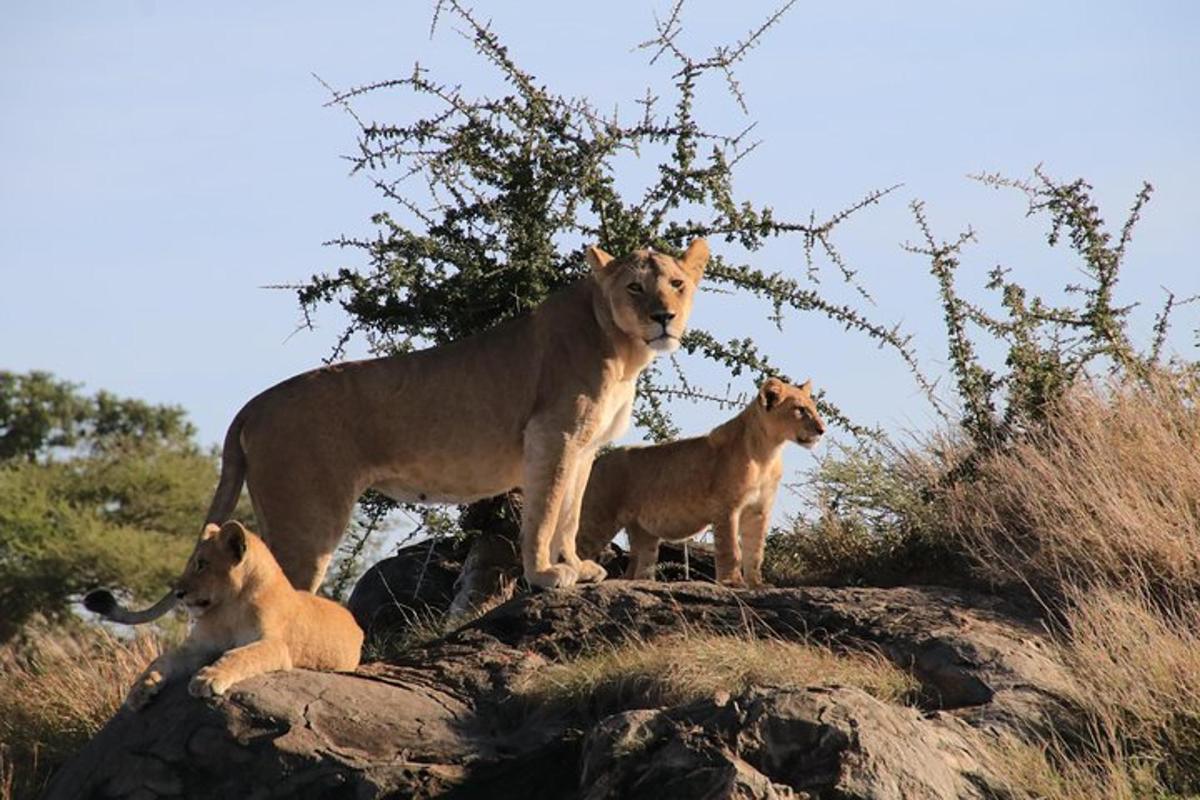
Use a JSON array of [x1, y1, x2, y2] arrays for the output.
[[521, 421, 580, 589]]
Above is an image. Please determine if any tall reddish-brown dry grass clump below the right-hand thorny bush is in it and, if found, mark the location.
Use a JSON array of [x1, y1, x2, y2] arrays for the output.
[[938, 373, 1200, 596]]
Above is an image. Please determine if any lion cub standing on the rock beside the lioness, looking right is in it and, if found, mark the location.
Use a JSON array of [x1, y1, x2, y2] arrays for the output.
[[577, 378, 824, 588]]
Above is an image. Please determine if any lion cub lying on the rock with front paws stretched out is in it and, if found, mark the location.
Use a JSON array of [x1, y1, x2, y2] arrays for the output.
[[117, 522, 362, 710]]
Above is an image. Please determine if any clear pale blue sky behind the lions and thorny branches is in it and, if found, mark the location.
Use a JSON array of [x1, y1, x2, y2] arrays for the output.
[[0, 0, 1200, 513]]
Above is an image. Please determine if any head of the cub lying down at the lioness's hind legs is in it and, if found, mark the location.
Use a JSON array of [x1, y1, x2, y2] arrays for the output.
[[175, 522, 252, 618]]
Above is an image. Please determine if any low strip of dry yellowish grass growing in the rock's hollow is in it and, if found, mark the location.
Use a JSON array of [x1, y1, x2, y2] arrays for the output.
[[514, 632, 917, 710]]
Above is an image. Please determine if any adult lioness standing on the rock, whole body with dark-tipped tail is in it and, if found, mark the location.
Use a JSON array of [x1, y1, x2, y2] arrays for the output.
[[96, 239, 708, 621]]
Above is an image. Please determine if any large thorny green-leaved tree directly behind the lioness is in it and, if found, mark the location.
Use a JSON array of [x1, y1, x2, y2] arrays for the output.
[[294, 0, 929, 594]]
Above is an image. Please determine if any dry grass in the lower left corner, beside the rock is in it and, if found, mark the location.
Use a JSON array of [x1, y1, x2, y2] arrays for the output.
[[0, 628, 162, 800]]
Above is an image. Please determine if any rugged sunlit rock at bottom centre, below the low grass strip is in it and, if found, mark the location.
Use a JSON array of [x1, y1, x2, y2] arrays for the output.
[[582, 687, 994, 800]]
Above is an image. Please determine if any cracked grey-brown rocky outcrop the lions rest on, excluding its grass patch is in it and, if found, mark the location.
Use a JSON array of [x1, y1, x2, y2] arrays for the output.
[[47, 581, 1067, 800]]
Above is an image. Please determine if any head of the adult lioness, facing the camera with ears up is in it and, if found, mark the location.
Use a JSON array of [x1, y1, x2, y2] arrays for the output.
[[587, 239, 708, 353]]
